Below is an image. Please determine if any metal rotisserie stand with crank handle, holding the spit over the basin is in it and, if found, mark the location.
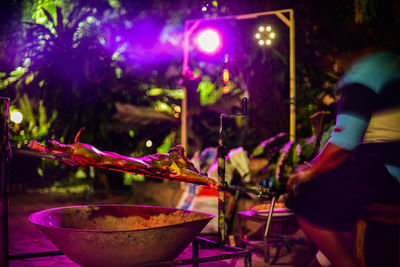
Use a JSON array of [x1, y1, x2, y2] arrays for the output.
[[0, 97, 275, 266]]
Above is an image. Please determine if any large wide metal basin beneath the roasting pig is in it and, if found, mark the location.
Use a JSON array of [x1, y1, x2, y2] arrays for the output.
[[29, 205, 215, 266]]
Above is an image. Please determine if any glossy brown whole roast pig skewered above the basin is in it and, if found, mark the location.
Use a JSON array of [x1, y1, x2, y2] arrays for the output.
[[28, 128, 221, 188]]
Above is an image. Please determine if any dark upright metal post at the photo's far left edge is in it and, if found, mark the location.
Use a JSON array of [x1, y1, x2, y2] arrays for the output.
[[0, 97, 11, 266]]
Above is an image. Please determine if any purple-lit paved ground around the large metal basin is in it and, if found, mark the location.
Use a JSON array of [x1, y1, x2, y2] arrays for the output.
[[4, 183, 311, 267]]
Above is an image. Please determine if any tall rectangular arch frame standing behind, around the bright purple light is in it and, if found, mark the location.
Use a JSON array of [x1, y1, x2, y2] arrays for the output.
[[181, 9, 296, 150]]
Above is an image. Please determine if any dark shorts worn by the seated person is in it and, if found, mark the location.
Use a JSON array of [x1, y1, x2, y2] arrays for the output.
[[286, 159, 400, 232]]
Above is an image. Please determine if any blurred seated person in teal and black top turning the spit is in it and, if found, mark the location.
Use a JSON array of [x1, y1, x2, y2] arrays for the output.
[[286, 47, 400, 267]]
